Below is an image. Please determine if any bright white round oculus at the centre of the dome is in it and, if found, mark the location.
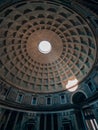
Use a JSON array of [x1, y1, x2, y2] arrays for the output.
[[38, 41, 52, 54]]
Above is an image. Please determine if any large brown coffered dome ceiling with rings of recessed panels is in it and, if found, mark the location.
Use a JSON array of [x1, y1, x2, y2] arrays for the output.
[[0, 1, 96, 93]]
